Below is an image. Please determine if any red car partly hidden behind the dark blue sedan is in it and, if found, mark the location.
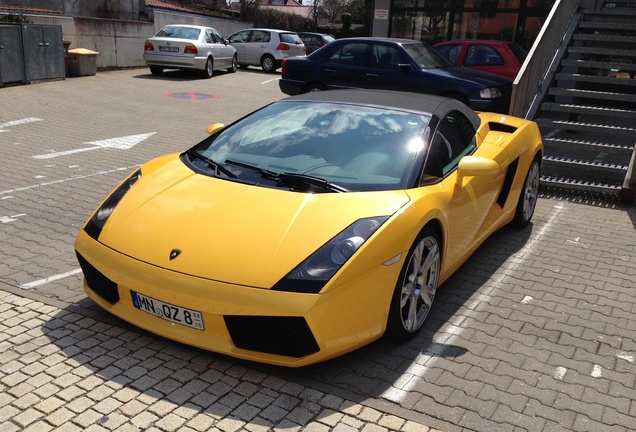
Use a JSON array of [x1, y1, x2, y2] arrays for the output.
[[434, 40, 528, 81]]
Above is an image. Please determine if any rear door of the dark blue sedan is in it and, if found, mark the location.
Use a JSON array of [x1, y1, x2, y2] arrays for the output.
[[320, 42, 368, 89]]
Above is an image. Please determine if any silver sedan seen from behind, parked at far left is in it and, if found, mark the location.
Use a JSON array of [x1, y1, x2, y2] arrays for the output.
[[144, 24, 238, 78]]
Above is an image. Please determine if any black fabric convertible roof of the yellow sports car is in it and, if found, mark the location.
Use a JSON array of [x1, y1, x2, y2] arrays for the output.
[[284, 89, 481, 129]]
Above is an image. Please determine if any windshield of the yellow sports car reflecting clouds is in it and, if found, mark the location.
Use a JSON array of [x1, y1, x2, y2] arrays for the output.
[[186, 100, 430, 192]]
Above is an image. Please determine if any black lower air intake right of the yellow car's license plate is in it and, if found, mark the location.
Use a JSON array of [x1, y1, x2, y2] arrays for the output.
[[224, 315, 320, 358]]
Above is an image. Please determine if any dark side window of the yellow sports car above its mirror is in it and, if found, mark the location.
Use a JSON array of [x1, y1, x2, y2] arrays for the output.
[[422, 111, 477, 183]]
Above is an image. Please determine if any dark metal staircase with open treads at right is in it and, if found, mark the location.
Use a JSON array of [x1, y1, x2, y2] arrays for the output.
[[534, 1, 636, 202]]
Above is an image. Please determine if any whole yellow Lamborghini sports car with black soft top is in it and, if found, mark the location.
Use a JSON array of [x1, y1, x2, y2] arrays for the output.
[[75, 90, 543, 367]]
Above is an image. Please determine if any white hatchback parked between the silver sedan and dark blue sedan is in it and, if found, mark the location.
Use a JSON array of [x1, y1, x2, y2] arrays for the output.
[[227, 29, 306, 72]]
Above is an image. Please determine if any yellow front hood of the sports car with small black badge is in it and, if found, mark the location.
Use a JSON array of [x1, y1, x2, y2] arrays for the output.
[[99, 155, 409, 288]]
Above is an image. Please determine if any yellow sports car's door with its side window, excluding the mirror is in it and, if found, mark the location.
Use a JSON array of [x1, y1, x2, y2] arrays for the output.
[[425, 111, 508, 263]]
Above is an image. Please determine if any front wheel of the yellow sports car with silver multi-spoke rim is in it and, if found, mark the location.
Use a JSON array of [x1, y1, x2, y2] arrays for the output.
[[384, 227, 441, 341]]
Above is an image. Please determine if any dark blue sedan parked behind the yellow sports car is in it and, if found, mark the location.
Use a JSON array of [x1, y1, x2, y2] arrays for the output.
[[279, 38, 512, 113]]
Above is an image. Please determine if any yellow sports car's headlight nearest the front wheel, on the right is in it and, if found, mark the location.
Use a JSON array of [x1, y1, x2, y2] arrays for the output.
[[272, 216, 389, 293]]
